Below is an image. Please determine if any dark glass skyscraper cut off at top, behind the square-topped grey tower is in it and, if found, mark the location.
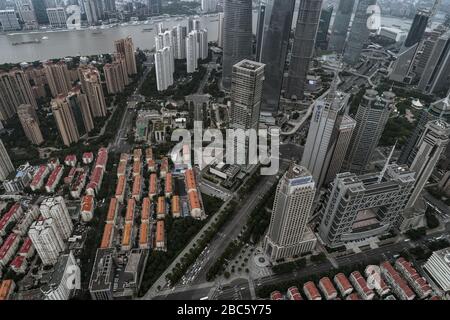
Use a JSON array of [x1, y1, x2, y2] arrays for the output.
[[222, 0, 252, 90]]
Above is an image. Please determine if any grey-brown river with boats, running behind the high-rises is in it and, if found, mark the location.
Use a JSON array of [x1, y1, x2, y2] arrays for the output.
[[0, 12, 428, 63]]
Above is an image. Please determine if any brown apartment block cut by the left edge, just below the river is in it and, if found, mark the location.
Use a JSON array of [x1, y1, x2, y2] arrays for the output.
[[0, 69, 37, 120]]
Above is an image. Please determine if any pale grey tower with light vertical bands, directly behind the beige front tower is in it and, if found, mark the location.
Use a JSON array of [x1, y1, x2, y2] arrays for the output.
[[301, 82, 350, 188]]
